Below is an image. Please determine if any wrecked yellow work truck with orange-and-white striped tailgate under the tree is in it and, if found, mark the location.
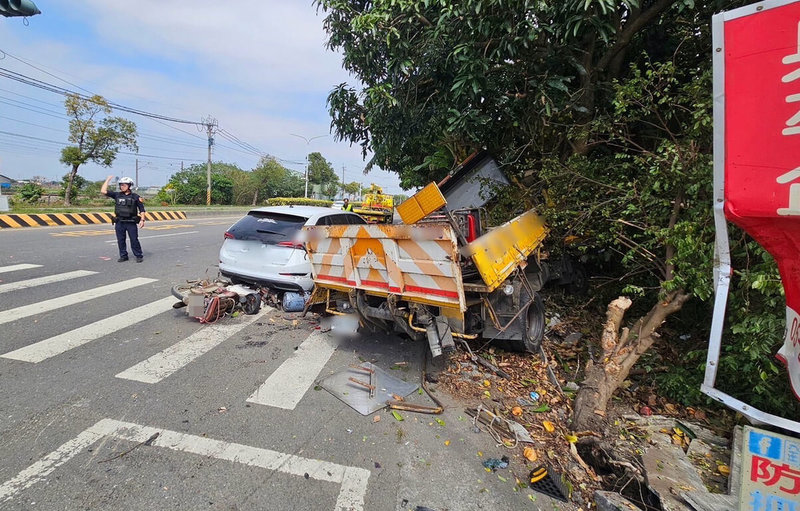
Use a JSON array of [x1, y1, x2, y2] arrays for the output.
[[305, 154, 547, 357]]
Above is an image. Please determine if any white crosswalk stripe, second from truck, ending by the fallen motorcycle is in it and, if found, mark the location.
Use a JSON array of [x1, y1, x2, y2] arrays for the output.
[[116, 307, 273, 383]]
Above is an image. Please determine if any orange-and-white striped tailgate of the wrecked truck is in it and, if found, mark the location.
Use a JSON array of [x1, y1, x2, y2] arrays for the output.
[[304, 224, 467, 313]]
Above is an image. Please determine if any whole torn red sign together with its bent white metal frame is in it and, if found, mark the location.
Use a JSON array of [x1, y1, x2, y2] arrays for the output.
[[701, 0, 800, 433]]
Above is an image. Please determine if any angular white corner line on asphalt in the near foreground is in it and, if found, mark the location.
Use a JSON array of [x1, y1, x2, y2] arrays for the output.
[[0, 419, 370, 511]]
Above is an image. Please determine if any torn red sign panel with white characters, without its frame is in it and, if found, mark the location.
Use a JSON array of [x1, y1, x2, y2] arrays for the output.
[[724, 2, 800, 399]]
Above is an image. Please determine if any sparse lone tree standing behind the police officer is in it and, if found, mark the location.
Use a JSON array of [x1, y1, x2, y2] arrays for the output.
[[61, 94, 137, 206]]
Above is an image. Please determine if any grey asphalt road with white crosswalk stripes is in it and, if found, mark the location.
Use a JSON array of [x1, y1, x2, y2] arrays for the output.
[[0, 217, 573, 511]]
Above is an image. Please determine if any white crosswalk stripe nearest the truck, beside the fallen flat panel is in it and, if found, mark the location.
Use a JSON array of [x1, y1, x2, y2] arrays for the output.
[[247, 330, 336, 410]]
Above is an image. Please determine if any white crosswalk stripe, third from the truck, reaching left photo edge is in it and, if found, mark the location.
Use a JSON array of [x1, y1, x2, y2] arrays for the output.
[[0, 297, 175, 364]]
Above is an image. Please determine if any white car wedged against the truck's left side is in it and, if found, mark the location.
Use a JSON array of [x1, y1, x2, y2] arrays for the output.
[[219, 206, 366, 293]]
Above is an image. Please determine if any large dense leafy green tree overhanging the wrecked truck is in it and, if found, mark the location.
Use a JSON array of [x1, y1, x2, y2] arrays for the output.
[[317, 0, 800, 429]]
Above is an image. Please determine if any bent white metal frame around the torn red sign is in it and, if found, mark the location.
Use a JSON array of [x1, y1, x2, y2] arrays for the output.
[[700, 0, 800, 433]]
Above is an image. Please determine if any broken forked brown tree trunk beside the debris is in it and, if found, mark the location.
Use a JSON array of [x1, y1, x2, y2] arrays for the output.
[[572, 290, 690, 431]]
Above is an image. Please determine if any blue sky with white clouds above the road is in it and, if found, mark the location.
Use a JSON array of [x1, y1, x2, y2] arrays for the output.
[[0, 0, 402, 193]]
